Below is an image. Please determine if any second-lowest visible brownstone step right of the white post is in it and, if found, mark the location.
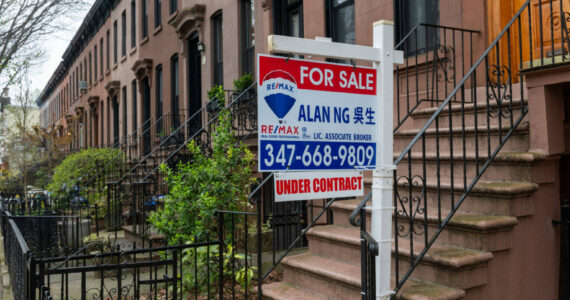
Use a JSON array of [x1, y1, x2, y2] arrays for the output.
[[392, 240, 493, 290]]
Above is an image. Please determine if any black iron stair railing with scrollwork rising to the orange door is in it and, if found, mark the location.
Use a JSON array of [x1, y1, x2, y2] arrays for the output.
[[348, 0, 570, 292]]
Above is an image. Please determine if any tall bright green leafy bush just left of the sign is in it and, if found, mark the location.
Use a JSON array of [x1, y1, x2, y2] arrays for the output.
[[150, 112, 255, 243]]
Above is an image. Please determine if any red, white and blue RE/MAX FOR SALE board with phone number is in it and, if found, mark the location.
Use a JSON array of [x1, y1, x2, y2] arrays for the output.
[[257, 55, 380, 171]]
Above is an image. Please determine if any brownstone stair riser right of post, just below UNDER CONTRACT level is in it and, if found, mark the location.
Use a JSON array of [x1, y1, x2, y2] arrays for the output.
[[394, 185, 534, 216]]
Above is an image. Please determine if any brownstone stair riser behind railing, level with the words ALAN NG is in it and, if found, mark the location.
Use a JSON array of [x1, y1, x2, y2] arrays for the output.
[[413, 103, 521, 128]]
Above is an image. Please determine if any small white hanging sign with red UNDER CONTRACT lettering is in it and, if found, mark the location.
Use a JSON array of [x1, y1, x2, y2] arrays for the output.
[[274, 171, 364, 202]]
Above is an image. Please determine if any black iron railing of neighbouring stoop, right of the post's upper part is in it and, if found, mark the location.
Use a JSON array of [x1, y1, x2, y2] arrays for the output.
[[394, 23, 480, 132]]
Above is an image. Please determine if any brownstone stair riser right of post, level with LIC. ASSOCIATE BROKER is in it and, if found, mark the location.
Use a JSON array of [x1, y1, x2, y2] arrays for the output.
[[394, 131, 529, 155]]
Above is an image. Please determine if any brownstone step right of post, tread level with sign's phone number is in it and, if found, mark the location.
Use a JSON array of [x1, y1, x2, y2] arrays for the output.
[[396, 149, 545, 184]]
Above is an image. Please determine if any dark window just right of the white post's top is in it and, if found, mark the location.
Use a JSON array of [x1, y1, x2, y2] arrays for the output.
[[395, 0, 439, 56]]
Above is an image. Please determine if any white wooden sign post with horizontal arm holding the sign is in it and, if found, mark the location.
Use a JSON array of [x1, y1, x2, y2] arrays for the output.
[[266, 21, 403, 299]]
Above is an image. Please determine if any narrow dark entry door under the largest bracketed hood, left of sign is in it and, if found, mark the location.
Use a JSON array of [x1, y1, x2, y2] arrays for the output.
[[188, 32, 202, 136]]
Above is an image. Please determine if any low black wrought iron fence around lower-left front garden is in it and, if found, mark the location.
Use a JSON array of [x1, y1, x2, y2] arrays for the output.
[[5, 211, 262, 300]]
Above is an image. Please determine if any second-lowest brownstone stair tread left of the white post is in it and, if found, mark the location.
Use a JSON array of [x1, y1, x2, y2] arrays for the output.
[[283, 252, 360, 287]]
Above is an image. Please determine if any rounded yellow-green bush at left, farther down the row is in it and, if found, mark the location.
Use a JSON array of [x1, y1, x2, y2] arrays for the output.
[[47, 148, 124, 206]]
